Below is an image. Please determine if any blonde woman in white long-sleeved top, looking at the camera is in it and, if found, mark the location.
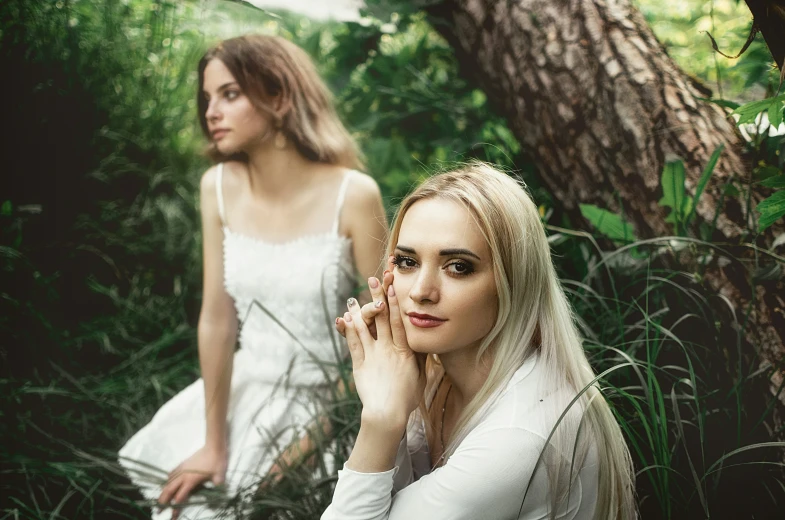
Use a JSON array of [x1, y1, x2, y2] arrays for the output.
[[322, 163, 636, 520]]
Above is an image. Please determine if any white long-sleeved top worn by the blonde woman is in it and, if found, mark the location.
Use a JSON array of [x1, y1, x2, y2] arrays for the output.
[[322, 355, 599, 520]]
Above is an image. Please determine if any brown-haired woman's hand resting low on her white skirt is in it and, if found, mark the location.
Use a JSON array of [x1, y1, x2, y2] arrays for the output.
[[158, 446, 228, 520]]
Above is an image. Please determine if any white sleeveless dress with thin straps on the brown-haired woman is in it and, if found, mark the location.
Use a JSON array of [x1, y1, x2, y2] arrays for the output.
[[119, 164, 355, 520]]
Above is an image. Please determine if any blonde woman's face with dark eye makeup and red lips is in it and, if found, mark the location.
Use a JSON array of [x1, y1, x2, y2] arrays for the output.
[[393, 198, 498, 355]]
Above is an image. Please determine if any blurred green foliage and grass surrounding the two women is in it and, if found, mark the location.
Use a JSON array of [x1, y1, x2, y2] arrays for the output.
[[0, 0, 785, 520]]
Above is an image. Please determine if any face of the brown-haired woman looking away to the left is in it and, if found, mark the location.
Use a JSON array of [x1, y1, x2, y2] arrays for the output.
[[202, 58, 269, 155]]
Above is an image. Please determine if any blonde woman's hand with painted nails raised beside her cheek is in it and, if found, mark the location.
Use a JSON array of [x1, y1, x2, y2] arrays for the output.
[[336, 274, 424, 427]]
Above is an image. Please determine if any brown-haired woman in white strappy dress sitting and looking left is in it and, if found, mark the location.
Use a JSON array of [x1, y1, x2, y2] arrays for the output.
[[120, 35, 386, 519]]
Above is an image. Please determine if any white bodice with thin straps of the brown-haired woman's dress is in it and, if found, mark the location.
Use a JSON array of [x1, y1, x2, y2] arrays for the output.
[[217, 165, 355, 385]]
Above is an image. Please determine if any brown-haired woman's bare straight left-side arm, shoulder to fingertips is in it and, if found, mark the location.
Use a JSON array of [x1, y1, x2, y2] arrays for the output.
[[158, 168, 237, 519]]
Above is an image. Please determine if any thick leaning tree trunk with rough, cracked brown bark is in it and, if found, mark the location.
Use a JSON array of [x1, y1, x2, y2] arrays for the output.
[[425, 0, 785, 403]]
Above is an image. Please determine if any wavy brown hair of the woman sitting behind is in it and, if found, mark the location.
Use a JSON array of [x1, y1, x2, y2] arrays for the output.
[[196, 34, 362, 168]]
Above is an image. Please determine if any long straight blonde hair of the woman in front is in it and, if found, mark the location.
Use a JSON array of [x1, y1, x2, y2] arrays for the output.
[[388, 162, 636, 520]]
